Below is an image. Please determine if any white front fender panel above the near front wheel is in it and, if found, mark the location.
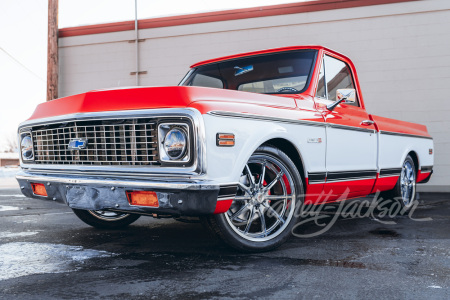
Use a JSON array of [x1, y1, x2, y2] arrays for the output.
[[203, 114, 325, 183]]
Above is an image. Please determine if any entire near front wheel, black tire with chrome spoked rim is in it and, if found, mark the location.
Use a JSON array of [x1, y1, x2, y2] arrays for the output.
[[204, 146, 304, 252]]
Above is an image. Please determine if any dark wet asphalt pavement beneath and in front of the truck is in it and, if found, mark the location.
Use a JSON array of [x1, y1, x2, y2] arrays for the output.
[[0, 189, 450, 299]]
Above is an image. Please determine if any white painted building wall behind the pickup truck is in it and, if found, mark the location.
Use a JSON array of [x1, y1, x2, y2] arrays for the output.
[[60, 0, 450, 192]]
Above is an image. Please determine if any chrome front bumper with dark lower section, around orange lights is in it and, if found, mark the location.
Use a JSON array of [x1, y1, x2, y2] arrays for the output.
[[16, 171, 237, 216]]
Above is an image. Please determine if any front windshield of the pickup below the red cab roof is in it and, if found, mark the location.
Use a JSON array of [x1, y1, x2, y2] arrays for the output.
[[181, 50, 317, 94]]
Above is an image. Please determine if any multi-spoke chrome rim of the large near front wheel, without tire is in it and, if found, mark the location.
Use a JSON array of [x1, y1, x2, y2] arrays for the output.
[[225, 154, 296, 242]]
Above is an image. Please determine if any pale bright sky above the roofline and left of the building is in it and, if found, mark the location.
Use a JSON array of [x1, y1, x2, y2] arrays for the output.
[[0, 0, 308, 152]]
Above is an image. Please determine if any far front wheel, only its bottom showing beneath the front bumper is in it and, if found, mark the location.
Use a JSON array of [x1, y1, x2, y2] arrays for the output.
[[72, 208, 140, 229]]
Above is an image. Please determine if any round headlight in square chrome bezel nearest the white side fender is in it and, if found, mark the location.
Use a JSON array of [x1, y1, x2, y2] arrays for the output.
[[158, 123, 189, 163]]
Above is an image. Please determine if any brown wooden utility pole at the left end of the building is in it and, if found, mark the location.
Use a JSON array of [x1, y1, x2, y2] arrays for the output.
[[47, 0, 59, 101]]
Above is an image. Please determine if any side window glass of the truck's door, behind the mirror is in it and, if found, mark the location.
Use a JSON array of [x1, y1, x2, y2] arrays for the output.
[[319, 55, 359, 106]]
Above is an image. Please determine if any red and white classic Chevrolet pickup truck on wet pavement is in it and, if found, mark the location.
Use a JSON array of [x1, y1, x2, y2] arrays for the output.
[[17, 46, 433, 251]]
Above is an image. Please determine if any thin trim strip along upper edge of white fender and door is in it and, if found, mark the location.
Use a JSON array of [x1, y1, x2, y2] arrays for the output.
[[208, 110, 375, 133]]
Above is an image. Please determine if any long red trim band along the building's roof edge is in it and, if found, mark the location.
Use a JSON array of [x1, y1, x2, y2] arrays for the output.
[[59, 0, 420, 37]]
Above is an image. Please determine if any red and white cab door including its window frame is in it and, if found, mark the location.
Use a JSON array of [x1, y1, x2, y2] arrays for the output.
[[316, 55, 377, 201]]
